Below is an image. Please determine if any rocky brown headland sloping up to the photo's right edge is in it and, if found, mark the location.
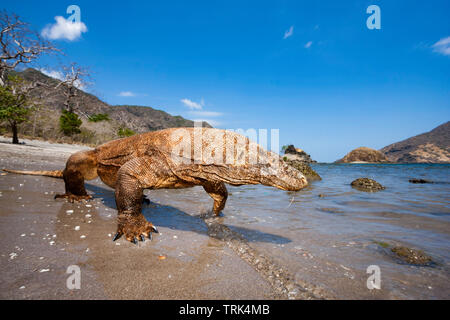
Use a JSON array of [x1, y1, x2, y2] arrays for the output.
[[380, 121, 450, 163]]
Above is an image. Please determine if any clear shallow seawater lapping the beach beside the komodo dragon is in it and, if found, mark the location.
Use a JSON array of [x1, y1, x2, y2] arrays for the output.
[[151, 164, 450, 299]]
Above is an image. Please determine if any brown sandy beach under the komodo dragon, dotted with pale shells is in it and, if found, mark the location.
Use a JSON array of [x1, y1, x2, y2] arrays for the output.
[[0, 138, 324, 299]]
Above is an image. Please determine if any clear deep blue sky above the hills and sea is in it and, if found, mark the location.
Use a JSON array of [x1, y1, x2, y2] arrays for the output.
[[2, 0, 450, 161]]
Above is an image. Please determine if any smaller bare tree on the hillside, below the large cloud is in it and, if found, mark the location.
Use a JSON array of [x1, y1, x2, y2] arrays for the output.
[[55, 62, 90, 113]]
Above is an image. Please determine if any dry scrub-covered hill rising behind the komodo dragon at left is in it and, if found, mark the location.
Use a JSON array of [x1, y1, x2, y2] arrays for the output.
[[2, 68, 211, 144]]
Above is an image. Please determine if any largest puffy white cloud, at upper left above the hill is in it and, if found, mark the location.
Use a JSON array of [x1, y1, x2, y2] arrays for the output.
[[41, 16, 87, 41]]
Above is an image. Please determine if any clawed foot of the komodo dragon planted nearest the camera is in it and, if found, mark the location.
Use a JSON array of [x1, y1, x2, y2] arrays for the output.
[[113, 214, 159, 244]]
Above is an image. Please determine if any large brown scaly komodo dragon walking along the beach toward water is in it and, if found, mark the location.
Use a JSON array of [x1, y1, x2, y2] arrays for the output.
[[4, 128, 308, 244]]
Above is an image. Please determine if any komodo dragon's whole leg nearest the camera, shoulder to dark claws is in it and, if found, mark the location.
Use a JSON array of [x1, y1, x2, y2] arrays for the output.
[[113, 157, 158, 244]]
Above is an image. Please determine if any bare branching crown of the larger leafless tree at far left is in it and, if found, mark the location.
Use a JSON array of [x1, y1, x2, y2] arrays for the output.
[[0, 10, 59, 86]]
